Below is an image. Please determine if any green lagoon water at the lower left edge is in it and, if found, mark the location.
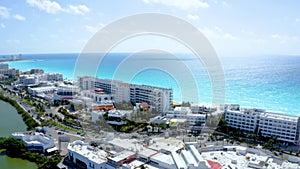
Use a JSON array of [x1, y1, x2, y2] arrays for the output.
[[0, 101, 37, 169]]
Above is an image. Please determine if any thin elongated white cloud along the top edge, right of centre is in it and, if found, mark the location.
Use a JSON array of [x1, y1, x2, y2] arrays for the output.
[[143, 0, 209, 10]]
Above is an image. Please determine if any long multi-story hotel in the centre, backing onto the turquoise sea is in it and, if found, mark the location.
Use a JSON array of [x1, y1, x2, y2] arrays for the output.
[[78, 76, 173, 112]]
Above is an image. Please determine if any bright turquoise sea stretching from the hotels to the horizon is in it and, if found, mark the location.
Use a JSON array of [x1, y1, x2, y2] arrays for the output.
[[9, 53, 300, 115]]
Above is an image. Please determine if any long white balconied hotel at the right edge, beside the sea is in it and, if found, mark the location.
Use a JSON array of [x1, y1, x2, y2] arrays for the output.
[[225, 106, 300, 144]]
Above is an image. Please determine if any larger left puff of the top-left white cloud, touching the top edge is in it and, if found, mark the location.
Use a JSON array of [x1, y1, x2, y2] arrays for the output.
[[26, 0, 63, 14]]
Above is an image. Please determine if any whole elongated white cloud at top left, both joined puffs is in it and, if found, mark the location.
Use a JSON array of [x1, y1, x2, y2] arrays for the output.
[[27, 0, 90, 15]]
